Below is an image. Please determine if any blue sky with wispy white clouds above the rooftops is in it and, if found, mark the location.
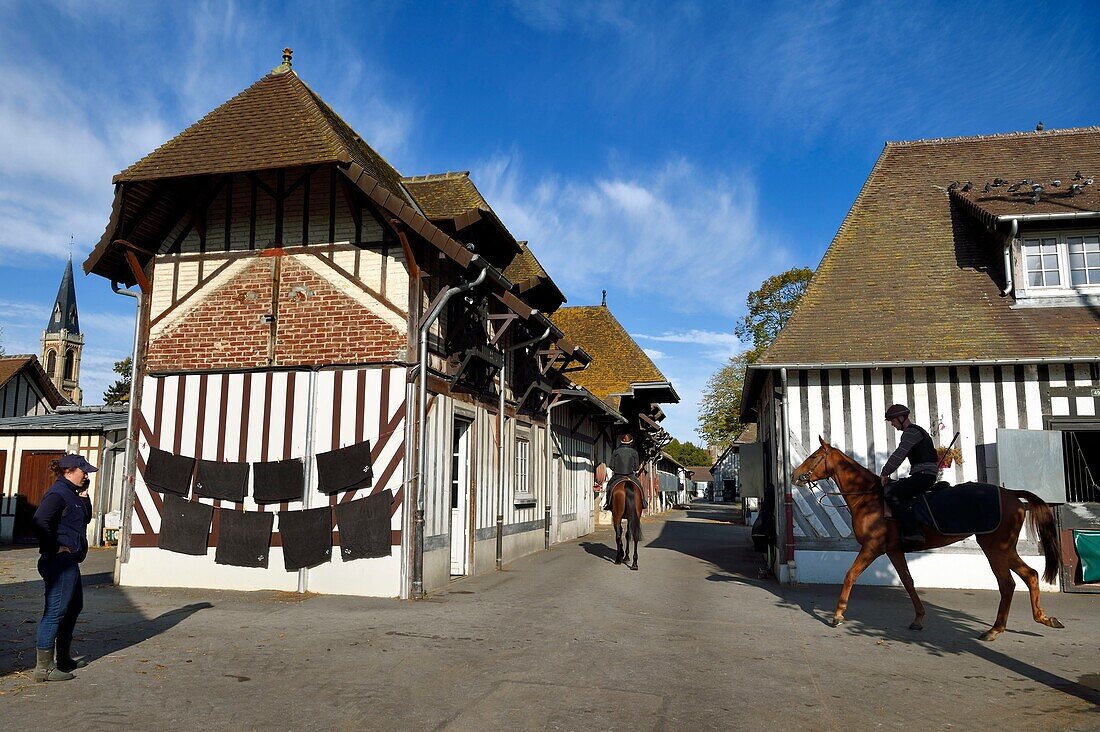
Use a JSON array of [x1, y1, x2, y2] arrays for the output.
[[0, 0, 1100, 441]]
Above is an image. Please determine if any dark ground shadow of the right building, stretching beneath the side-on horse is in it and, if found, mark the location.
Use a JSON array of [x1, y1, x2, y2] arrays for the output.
[[644, 499, 1100, 711]]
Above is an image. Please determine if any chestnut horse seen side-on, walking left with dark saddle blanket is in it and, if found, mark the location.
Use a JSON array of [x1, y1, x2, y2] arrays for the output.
[[793, 437, 1065, 641]]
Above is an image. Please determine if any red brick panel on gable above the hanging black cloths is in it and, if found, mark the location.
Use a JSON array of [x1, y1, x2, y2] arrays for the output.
[[146, 256, 406, 372]]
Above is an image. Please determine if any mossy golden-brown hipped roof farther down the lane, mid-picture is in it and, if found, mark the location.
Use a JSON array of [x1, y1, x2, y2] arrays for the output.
[[550, 305, 668, 407]]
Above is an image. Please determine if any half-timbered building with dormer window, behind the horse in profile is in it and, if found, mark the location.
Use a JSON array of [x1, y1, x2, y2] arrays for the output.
[[741, 128, 1100, 590]]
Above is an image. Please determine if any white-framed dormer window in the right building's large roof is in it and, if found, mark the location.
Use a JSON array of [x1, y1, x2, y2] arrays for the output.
[[1020, 232, 1100, 296]]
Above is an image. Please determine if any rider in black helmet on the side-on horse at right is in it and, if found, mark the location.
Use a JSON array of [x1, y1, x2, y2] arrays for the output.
[[880, 404, 939, 543]]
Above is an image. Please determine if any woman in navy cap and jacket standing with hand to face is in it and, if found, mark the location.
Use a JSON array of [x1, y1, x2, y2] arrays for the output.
[[34, 454, 99, 681]]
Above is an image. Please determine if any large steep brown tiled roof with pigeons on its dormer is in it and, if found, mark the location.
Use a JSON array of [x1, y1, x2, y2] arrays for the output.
[[759, 128, 1100, 365]]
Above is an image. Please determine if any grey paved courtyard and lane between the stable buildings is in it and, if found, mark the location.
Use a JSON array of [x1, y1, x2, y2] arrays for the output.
[[0, 505, 1100, 730]]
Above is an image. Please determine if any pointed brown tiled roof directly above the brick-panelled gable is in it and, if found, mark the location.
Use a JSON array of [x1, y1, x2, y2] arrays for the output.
[[114, 70, 408, 200]]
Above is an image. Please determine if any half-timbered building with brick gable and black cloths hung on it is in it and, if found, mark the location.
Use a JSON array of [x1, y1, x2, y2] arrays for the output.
[[85, 54, 670, 598]]
